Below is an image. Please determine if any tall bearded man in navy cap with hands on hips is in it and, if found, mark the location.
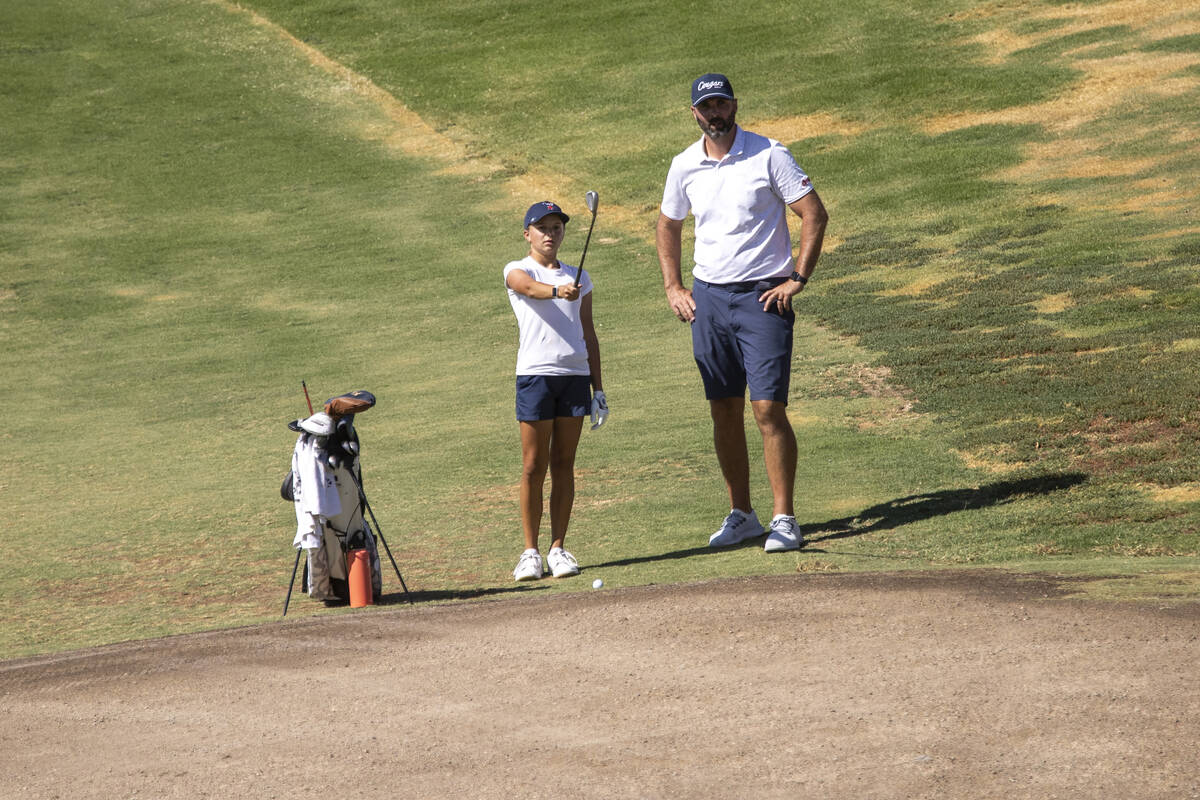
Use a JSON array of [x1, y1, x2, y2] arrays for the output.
[[656, 73, 828, 553]]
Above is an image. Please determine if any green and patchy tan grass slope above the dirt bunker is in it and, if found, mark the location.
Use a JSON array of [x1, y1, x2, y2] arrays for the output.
[[0, 0, 1200, 657]]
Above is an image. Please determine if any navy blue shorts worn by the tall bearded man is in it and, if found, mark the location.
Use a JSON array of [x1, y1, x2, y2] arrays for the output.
[[691, 278, 796, 403]]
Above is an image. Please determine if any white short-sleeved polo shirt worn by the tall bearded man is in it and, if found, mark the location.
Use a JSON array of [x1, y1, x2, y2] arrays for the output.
[[661, 127, 812, 283]]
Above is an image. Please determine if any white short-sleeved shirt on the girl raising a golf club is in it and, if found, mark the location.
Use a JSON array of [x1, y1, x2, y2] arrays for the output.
[[504, 255, 592, 375]]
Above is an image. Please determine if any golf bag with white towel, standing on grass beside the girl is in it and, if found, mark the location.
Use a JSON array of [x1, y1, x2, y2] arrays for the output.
[[281, 400, 383, 613]]
